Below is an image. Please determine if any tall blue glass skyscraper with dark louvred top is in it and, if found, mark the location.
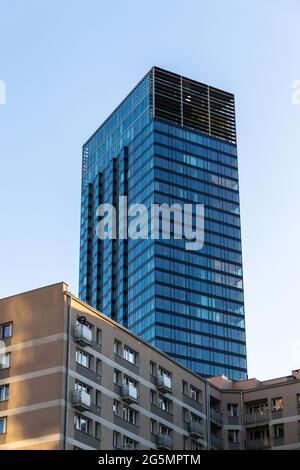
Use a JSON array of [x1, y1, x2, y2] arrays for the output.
[[79, 67, 247, 379]]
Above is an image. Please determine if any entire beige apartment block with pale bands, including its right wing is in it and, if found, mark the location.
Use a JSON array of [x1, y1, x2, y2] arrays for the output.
[[0, 283, 300, 450]]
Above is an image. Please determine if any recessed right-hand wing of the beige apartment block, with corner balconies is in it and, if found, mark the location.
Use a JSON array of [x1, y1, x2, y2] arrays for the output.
[[210, 370, 300, 450]]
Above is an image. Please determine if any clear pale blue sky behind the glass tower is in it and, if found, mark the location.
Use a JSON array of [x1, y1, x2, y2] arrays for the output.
[[0, 0, 300, 378]]
